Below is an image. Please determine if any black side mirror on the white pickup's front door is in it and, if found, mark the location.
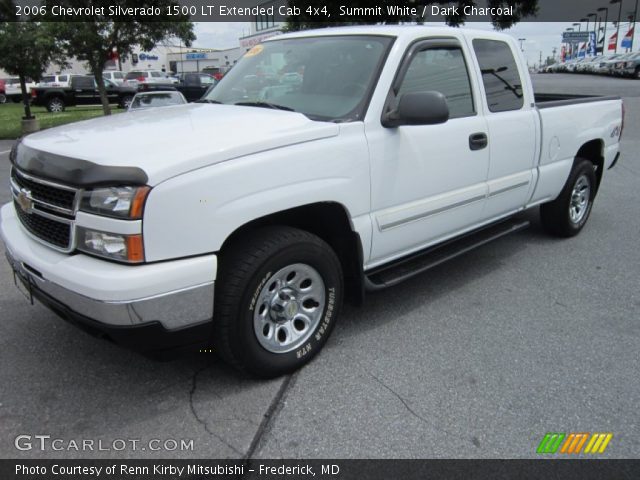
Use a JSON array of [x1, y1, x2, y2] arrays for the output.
[[382, 92, 449, 128]]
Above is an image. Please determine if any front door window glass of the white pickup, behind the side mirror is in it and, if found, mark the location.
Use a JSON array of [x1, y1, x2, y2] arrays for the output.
[[398, 47, 476, 118]]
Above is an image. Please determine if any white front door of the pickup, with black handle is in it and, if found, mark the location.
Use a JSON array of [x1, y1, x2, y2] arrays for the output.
[[365, 39, 489, 267]]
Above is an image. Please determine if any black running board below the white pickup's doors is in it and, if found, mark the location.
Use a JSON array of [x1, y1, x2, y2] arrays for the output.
[[364, 218, 530, 291]]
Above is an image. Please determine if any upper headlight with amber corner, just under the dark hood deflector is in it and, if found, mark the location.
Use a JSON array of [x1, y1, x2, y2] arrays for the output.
[[80, 187, 151, 219]]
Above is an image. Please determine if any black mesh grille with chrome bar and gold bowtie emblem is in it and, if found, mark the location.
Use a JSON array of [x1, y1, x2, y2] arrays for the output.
[[11, 167, 80, 252]]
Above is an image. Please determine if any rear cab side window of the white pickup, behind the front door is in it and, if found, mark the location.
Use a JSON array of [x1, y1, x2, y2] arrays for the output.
[[473, 39, 524, 112]]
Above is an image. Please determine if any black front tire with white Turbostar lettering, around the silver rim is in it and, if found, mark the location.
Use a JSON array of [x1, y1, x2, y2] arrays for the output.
[[211, 227, 343, 378]]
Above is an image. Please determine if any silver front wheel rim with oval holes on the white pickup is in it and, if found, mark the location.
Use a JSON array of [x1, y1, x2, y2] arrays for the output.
[[253, 263, 326, 353]]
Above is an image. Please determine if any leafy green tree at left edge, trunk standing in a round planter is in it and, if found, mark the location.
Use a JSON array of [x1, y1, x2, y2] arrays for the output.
[[0, 22, 63, 120]]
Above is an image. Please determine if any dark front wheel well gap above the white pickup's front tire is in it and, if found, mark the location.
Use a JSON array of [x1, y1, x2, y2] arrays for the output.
[[219, 202, 364, 305]]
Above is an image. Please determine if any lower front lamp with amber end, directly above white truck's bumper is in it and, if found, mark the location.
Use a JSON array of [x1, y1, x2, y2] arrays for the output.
[[77, 227, 144, 263]]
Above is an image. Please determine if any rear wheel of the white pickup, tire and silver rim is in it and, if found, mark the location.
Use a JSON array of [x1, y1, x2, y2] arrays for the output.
[[540, 158, 597, 237]]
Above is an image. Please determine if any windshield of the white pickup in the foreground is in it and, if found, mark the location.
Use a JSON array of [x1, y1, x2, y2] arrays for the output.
[[203, 35, 392, 121]]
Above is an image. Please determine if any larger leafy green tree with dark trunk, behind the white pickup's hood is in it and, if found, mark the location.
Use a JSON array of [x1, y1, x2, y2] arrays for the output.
[[51, 0, 195, 115]]
